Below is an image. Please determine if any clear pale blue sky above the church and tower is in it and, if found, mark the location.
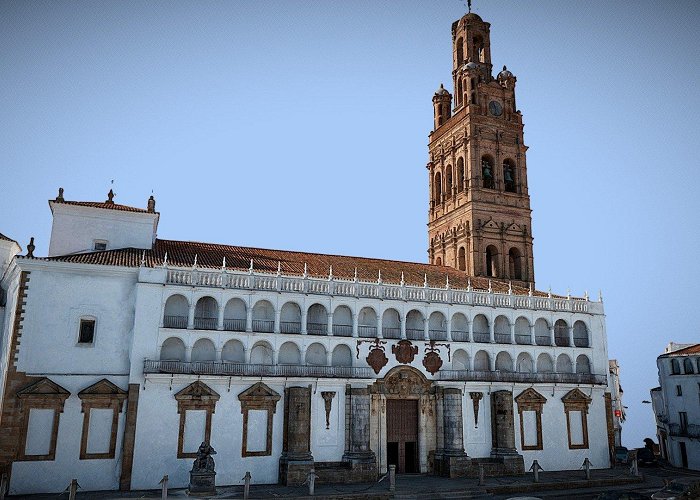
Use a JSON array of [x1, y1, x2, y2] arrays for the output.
[[0, 0, 700, 447]]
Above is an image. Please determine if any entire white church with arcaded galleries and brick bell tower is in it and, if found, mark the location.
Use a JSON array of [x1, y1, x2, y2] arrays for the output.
[[0, 9, 614, 494]]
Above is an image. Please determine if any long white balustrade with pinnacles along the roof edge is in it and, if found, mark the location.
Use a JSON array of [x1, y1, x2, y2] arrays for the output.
[[163, 267, 603, 314]]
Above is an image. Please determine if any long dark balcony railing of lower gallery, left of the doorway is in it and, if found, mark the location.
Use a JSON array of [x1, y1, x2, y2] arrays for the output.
[[143, 359, 374, 378]]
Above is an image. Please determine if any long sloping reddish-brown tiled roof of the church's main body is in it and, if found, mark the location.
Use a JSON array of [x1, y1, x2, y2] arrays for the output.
[[42, 239, 547, 296]]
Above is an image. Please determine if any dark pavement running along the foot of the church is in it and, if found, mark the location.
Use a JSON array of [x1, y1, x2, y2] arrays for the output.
[[9, 466, 700, 500]]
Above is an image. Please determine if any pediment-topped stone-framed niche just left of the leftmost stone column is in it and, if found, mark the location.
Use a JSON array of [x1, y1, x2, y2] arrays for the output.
[[238, 382, 281, 457]]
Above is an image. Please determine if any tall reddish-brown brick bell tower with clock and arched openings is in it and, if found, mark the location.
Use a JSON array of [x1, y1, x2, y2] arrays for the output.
[[427, 13, 535, 286]]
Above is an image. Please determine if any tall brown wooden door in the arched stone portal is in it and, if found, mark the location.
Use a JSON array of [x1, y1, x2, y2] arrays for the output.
[[386, 399, 419, 473]]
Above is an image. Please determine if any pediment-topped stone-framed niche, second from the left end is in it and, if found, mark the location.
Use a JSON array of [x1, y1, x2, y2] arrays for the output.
[[78, 378, 127, 460]]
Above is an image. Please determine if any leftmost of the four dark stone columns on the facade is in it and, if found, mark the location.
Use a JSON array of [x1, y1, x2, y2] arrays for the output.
[[279, 387, 314, 485]]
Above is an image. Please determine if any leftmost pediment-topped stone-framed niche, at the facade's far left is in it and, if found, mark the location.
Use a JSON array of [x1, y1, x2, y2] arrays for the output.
[[17, 377, 70, 461]]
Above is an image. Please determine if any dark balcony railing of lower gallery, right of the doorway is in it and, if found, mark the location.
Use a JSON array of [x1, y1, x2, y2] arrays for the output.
[[436, 370, 607, 385]]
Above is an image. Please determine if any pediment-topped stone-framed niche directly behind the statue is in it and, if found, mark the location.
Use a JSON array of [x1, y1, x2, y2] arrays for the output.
[[175, 380, 220, 458]]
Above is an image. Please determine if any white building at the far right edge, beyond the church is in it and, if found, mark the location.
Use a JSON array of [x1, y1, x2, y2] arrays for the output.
[[651, 343, 700, 470]]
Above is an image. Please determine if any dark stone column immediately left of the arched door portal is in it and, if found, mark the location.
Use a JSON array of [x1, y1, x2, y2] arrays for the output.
[[343, 385, 376, 464]]
